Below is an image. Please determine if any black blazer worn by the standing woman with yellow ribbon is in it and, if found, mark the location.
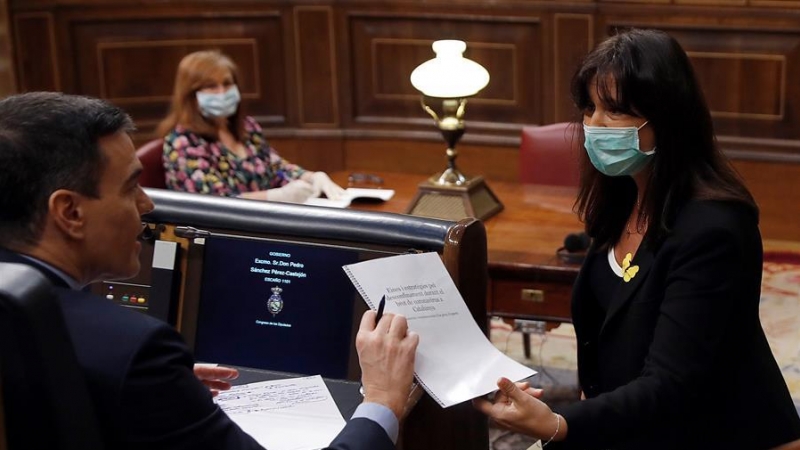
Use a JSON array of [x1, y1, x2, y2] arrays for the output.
[[552, 201, 800, 450]]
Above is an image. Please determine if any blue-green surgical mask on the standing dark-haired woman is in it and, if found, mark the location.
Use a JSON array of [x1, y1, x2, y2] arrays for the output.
[[583, 122, 656, 177]]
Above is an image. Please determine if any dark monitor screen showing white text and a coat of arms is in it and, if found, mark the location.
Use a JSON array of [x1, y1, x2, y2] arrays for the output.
[[194, 237, 377, 379]]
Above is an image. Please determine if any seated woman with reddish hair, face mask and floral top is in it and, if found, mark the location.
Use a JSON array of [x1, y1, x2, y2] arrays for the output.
[[157, 50, 344, 203]]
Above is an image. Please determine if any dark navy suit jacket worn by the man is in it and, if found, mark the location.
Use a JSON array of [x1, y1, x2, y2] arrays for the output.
[[0, 249, 394, 450]]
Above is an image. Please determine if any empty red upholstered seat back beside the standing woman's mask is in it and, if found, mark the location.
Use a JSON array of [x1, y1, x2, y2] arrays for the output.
[[519, 122, 583, 186]]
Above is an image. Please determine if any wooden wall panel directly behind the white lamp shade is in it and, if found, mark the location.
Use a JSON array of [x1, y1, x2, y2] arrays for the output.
[[348, 14, 542, 131]]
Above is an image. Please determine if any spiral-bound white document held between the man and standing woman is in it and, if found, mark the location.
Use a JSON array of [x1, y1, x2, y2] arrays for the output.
[[343, 252, 536, 408]]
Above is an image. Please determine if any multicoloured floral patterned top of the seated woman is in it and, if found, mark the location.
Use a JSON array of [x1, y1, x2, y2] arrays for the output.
[[163, 117, 305, 197]]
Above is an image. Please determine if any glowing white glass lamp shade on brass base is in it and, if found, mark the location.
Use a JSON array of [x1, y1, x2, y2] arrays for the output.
[[411, 40, 489, 98]]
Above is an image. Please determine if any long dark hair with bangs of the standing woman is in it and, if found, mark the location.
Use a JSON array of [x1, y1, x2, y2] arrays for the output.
[[572, 29, 758, 247]]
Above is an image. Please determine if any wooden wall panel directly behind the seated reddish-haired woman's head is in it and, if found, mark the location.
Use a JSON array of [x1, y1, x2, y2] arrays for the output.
[[70, 14, 288, 129]]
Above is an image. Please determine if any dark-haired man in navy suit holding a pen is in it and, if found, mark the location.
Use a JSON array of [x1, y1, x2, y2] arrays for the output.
[[0, 93, 418, 450]]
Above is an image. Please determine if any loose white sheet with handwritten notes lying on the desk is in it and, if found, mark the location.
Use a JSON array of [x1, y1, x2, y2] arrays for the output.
[[214, 375, 345, 450]]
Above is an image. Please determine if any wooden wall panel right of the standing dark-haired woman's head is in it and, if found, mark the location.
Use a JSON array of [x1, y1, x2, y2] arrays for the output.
[[668, 28, 800, 140]]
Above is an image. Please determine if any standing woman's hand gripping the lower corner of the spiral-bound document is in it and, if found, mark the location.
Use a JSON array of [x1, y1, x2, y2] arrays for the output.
[[472, 378, 567, 441]]
